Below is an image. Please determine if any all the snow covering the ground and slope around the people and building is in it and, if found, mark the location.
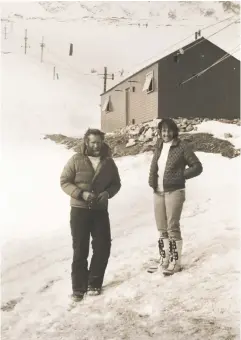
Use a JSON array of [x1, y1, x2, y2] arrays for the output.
[[0, 3, 241, 340]]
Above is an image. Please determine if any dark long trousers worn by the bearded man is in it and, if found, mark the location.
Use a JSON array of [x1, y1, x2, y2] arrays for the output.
[[70, 207, 111, 292]]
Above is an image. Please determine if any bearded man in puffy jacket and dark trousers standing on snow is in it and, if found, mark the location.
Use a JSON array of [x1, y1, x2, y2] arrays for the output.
[[60, 129, 121, 301]]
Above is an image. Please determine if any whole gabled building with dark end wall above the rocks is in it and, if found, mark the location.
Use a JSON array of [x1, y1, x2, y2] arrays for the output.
[[101, 38, 240, 132]]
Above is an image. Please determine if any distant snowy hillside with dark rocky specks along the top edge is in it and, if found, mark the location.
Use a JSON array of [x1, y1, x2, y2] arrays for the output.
[[1, 1, 240, 24]]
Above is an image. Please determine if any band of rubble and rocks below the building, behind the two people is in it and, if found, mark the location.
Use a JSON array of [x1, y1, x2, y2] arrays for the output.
[[45, 117, 241, 158]]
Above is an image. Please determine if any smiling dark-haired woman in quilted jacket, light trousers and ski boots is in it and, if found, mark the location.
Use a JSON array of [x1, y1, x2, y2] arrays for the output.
[[149, 118, 202, 275]]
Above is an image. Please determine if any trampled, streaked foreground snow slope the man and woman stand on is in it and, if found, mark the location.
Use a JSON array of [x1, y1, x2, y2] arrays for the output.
[[2, 153, 240, 340]]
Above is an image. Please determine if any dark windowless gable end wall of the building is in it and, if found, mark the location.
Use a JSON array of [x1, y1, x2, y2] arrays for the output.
[[158, 41, 240, 119]]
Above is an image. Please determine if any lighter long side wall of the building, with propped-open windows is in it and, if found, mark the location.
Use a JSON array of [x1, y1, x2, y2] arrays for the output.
[[101, 63, 158, 132]]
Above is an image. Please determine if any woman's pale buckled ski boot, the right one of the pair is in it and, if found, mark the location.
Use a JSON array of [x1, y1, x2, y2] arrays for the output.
[[163, 240, 182, 276]]
